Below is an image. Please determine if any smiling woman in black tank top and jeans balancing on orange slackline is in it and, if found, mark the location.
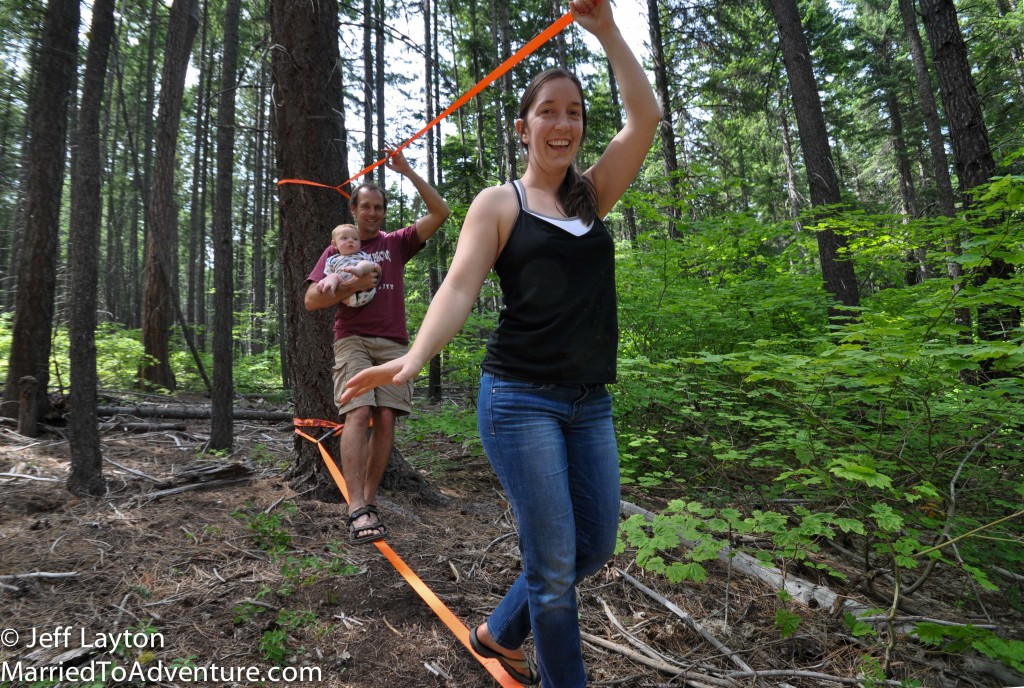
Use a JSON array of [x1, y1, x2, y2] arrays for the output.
[[342, 0, 662, 688]]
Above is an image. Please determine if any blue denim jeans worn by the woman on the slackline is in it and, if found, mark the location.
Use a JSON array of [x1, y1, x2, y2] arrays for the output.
[[477, 373, 618, 688]]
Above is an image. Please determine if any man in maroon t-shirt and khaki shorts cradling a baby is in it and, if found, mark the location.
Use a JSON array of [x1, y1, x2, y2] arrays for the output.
[[305, 152, 451, 544]]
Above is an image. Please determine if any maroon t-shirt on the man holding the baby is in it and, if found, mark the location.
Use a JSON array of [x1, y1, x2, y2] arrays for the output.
[[308, 224, 425, 344]]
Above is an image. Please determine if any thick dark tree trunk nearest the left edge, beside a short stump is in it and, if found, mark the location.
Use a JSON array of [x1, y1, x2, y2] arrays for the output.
[[3, 0, 79, 427]]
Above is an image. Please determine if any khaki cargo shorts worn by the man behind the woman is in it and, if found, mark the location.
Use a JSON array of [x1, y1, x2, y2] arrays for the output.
[[331, 335, 413, 416]]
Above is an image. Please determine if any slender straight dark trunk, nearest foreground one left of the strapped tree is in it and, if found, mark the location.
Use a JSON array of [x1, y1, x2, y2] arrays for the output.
[[210, 0, 242, 449]]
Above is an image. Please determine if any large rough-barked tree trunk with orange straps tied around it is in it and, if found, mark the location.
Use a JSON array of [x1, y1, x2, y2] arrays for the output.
[[270, 0, 354, 499]]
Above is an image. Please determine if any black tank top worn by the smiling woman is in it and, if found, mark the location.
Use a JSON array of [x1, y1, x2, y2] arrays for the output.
[[483, 182, 618, 384]]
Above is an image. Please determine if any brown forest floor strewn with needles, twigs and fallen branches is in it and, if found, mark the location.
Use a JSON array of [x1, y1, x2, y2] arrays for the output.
[[0, 397, 1024, 688]]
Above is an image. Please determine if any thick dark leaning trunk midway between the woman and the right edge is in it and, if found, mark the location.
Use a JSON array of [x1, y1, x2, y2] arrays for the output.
[[771, 0, 860, 317]]
